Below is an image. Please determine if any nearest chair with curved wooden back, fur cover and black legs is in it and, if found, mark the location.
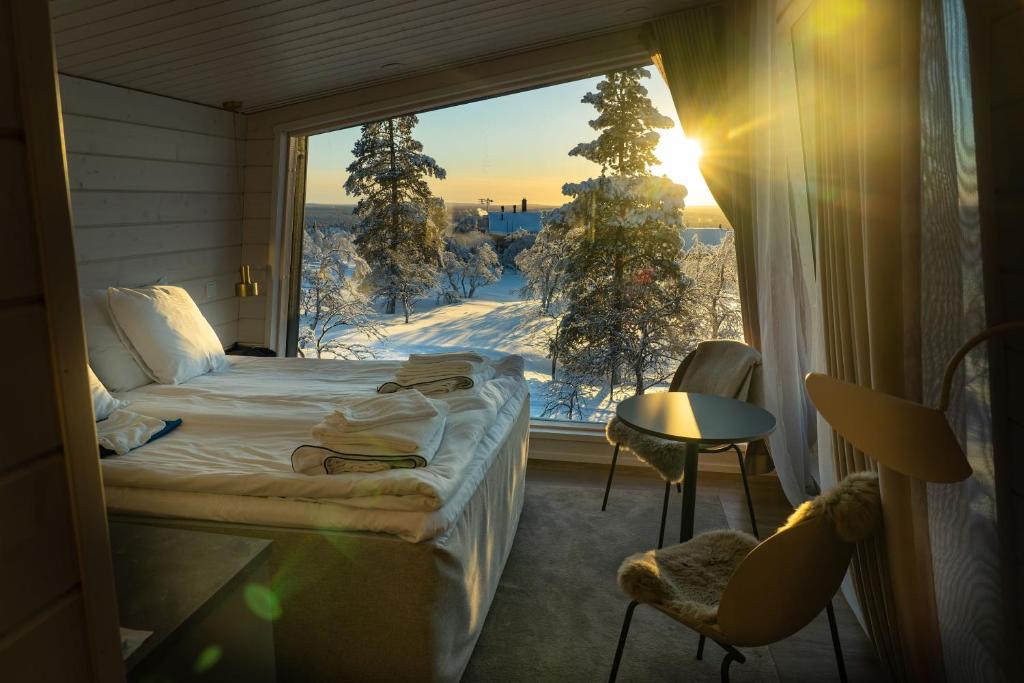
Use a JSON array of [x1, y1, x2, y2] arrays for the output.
[[609, 472, 882, 683]]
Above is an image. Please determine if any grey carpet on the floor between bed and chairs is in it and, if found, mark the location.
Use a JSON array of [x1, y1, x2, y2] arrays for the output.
[[463, 481, 778, 683]]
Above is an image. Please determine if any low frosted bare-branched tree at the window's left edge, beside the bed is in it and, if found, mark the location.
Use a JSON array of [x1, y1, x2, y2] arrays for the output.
[[298, 224, 384, 359]]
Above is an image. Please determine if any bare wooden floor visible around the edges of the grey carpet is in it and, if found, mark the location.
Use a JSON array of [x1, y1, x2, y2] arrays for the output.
[[526, 459, 887, 683]]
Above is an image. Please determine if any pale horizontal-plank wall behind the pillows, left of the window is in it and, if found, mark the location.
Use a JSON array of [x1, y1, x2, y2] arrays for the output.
[[61, 77, 244, 345]]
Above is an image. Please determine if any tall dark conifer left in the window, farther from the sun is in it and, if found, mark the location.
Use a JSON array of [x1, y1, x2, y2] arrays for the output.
[[344, 116, 446, 322]]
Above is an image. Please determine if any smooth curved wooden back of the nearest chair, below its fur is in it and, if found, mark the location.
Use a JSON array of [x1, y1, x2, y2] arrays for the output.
[[718, 516, 854, 647]]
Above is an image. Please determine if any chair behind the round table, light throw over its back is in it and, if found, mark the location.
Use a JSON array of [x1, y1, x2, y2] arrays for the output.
[[601, 339, 772, 548]]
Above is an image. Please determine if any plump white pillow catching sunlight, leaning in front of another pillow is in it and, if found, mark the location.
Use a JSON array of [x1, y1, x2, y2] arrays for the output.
[[106, 285, 228, 384]]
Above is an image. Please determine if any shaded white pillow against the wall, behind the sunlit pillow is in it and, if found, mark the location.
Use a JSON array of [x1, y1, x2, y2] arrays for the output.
[[82, 289, 153, 391]]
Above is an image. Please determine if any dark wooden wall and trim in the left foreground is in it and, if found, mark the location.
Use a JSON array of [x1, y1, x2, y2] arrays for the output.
[[0, 0, 124, 682]]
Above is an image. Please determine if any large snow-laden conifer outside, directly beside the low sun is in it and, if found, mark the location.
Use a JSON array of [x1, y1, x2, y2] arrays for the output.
[[536, 68, 688, 405]]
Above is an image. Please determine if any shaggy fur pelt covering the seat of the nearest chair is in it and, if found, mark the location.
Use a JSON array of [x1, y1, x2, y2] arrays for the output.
[[618, 529, 758, 624]]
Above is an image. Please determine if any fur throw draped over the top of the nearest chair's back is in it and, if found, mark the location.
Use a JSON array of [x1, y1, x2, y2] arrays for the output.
[[779, 472, 882, 543]]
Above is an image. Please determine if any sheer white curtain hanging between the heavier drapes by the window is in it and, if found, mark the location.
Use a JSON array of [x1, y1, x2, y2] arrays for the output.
[[750, 0, 821, 505]]
